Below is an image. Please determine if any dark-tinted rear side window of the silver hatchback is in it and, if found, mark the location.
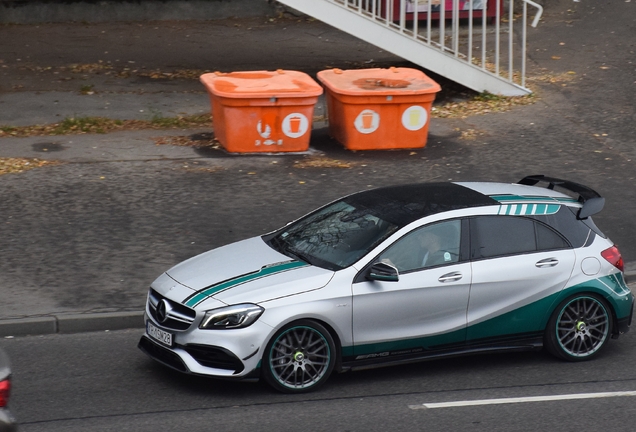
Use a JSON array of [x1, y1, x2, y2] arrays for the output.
[[470, 216, 570, 259]]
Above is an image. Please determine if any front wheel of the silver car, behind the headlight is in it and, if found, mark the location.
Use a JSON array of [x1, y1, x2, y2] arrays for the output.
[[263, 320, 336, 393]]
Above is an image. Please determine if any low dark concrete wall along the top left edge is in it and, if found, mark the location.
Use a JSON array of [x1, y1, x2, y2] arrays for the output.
[[0, 0, 276, 24]]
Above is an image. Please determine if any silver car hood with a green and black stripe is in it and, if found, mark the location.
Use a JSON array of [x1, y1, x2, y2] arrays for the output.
[[166, 237, 334, 309]]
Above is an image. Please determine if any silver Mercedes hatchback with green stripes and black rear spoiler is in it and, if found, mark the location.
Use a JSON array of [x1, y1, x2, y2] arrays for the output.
[[139, 176, 634, 392]]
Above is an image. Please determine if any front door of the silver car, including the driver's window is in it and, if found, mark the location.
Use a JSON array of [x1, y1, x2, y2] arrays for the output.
[[353, 220, 471, 358]]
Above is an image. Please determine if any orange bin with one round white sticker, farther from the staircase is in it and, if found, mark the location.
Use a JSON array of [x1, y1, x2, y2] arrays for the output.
[[201, 70, 322, 153]]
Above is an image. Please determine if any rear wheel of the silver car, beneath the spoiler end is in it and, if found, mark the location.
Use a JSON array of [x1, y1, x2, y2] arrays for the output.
[[546, 295, 612, 361]]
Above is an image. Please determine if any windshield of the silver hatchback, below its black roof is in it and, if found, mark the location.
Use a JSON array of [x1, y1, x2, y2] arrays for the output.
[[264, 200, 398, 270]]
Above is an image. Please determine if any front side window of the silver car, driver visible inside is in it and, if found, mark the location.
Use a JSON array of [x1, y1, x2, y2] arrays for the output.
[[378, 220, 461, 273]]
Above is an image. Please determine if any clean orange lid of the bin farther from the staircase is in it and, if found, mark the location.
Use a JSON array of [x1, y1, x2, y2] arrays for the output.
[[200, 69, 322, 99]]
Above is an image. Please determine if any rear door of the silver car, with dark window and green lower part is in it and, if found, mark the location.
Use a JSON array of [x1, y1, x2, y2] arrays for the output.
[[467, 216, 575, 342]]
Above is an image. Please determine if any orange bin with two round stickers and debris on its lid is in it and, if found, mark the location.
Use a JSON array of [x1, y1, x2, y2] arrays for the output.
[[318, 67, 441, 150]]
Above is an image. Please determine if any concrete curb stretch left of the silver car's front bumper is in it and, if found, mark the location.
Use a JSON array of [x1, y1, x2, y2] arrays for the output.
[[0, 311, 144, 337]]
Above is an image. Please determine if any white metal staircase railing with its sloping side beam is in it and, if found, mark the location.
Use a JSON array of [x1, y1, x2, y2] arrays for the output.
[[279, 0, 543, 95]]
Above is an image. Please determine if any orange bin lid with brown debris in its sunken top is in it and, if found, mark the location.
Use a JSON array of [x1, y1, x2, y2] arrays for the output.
[[318, 67, 442, 96]]
